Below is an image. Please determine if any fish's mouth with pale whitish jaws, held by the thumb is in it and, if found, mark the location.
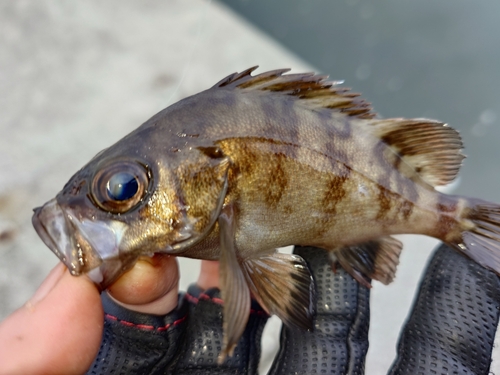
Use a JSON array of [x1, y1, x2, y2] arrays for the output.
[[32, 199, 126, 289]]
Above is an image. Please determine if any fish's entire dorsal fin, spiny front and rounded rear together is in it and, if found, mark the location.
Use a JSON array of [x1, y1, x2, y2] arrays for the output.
[[213, 66, 464, 186]]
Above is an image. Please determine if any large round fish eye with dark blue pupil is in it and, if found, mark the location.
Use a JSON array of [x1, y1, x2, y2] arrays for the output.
[[91, 162, 149, 213]]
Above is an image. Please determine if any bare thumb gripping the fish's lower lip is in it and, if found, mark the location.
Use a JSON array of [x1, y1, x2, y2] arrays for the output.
[[0, 264, 103, 374]]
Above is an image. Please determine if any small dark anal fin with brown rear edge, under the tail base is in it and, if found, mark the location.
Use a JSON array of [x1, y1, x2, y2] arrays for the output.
[[331, 236, 403, 288]]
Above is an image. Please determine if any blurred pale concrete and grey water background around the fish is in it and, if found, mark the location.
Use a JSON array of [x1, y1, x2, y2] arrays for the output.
[[0, 0, 500, 374]]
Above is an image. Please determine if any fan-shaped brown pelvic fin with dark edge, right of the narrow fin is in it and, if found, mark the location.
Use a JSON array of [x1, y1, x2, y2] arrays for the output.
[[243, 252, 315, 329]]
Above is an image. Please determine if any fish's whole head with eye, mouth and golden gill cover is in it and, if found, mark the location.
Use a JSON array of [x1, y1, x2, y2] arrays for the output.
[[32, 139, 229, 289]]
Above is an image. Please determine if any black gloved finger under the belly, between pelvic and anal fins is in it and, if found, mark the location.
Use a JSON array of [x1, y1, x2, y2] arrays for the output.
[[269, 247, 370, 375]]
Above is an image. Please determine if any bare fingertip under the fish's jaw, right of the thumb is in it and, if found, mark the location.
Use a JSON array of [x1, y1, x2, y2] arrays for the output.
[[107, 254, 179, 315]]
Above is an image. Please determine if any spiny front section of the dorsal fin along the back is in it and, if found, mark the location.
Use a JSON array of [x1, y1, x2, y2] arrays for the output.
[[213, 66, 376, 119]]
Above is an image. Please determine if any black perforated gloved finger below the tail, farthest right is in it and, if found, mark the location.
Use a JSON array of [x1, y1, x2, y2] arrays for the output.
[[390, 245, 500, 374]]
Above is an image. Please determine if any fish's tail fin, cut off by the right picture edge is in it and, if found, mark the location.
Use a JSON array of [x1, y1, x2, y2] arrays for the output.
[[455, 199, 500, 275]]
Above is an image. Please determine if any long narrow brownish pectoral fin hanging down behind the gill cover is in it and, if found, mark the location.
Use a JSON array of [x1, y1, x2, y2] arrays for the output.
[[218, 205, 250, 364]]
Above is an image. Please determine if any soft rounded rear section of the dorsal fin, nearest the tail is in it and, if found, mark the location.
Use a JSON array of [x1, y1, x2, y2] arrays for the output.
[[370, 118, 465, 186]]
